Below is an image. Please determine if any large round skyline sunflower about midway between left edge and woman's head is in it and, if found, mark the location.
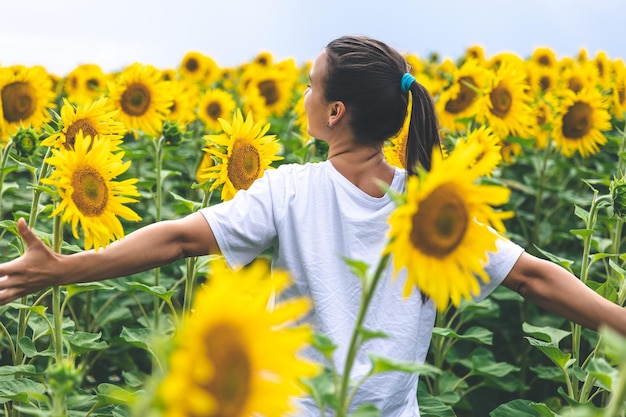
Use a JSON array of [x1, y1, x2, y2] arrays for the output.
[[109, 62, 173, 137]]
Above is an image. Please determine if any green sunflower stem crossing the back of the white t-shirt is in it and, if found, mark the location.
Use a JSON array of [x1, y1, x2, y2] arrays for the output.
[[337, 254, 391, 417]]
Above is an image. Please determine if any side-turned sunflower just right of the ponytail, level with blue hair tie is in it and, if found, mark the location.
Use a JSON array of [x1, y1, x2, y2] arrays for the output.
[[436, 60, 489, 132]]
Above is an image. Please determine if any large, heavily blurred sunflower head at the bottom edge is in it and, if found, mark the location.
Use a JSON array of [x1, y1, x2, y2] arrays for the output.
[[157, 260, 320, 417]]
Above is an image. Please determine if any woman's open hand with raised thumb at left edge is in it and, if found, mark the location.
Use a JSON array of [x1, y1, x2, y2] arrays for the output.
[[0, 219, 60, 305]]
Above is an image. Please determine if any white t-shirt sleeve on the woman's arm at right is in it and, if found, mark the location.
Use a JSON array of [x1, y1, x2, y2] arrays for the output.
[[474, 231, 524, 301]]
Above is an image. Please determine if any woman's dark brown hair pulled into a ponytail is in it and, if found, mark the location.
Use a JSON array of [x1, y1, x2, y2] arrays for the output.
[[324, 36, 439, 174]]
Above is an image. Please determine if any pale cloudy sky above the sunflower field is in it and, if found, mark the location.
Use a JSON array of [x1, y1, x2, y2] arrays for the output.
[[0, 0, 626, 75]]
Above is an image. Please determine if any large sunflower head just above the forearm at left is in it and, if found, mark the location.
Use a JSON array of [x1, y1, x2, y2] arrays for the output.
[[41, 130, 141, 250]]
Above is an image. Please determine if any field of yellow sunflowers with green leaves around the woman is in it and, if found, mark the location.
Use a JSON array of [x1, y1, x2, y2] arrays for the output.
[[0, 46, 626, 417]]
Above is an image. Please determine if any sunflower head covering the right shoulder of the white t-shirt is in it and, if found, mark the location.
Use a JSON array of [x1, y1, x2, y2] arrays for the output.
[[385, 146, 511, 311]]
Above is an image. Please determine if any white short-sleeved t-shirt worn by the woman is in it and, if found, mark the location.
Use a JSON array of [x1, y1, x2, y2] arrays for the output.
[[202, 161, 523, 417]]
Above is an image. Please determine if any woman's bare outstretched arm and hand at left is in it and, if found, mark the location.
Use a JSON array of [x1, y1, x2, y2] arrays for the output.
[[0, 213, 219, 305]]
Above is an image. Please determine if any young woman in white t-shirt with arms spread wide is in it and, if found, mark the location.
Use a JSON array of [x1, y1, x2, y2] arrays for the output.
[[0, 36, 626, 416]]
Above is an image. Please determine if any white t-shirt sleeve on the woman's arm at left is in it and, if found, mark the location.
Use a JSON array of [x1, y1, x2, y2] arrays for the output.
[[200, 172, 277, 268]]
